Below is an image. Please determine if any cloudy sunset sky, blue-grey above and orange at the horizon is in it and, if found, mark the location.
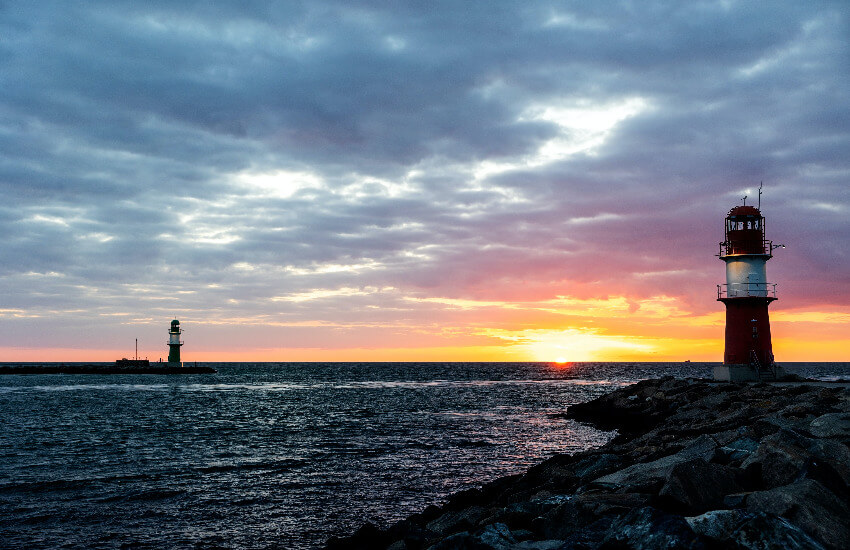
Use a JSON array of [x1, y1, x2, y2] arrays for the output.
[[0, 0, 850, 363]]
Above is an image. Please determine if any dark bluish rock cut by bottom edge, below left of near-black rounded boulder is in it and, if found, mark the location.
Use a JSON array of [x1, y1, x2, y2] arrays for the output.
[[602, 506, 705, 550]]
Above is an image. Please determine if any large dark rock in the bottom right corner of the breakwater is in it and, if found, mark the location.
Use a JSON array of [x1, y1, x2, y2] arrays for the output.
[[747, 479, 850, 550]]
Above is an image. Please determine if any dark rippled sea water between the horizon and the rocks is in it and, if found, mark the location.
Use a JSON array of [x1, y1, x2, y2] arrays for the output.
[[0, 363, 850, 549]]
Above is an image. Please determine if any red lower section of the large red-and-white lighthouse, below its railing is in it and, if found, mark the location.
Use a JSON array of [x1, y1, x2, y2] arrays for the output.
[[720, 296, 775, 366]]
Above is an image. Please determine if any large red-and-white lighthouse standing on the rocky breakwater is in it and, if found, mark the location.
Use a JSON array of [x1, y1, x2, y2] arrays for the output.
[[714, 199, 783, 382]]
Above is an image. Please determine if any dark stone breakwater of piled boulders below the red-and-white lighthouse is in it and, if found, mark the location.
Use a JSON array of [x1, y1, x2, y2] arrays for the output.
[[327, 378, 850, 550]]
